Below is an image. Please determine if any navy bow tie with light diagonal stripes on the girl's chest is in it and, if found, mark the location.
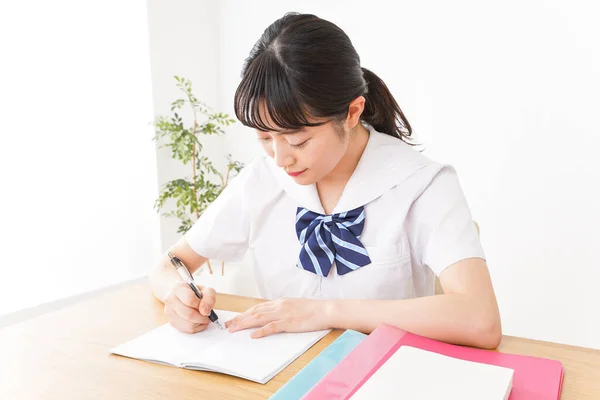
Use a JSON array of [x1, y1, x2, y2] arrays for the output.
[[296, 207, 371, 276]]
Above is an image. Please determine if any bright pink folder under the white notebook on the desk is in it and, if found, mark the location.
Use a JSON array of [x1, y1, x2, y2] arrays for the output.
[[302, 324, 563, 400]]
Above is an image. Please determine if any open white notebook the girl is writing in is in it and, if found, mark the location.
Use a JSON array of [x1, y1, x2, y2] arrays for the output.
[[110, 310, 329, 384]]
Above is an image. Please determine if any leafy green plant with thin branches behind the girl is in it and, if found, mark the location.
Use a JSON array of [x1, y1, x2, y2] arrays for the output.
[[154, 76, 243, 275]]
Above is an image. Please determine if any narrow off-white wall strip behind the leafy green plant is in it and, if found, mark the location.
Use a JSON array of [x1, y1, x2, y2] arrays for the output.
[[148, 0, 225, 250]]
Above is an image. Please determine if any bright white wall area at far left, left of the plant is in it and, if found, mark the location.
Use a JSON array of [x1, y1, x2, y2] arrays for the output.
[[0, 0, 160, 317]]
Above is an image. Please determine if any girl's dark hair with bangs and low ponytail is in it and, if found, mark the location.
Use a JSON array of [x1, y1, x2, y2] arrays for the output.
[[234, 13, 412, 142]]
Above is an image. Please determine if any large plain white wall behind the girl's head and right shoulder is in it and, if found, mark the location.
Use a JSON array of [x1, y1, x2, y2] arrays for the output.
[[151, 0, 600, 348]]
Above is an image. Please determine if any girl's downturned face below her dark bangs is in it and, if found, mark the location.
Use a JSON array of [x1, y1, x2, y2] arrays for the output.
[[257, 121, 349, 185]]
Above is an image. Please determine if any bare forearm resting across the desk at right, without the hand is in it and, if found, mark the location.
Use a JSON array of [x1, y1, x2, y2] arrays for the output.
[[328, 294, 501, 348]]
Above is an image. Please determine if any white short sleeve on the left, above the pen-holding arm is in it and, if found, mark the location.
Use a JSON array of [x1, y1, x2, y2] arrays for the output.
[[185, 159, 256, 261]]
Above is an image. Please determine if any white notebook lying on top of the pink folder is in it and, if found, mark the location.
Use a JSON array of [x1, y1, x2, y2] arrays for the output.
[[350, 346, 514, 400]]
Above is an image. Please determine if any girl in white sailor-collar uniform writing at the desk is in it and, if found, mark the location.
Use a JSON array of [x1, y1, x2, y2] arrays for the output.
[[150, 13, 501, 348]]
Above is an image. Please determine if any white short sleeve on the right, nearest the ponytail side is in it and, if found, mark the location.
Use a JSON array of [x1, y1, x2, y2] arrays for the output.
[[406, 166, 485, 275]]
